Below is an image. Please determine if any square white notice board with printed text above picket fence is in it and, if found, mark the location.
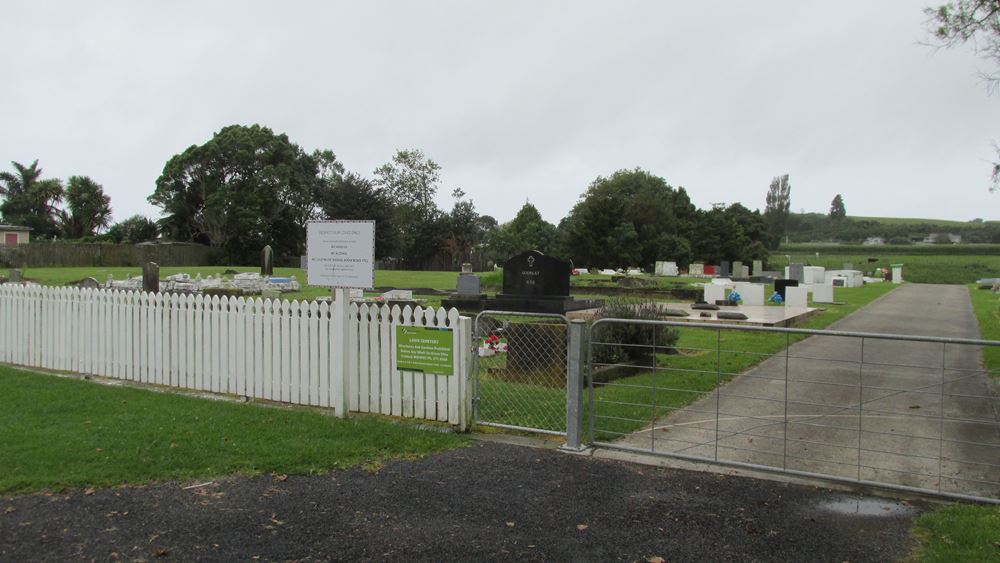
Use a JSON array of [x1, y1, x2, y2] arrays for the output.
[[306, 221, 375, 289]]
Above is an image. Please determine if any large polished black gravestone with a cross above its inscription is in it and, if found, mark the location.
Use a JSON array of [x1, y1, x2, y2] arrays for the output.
[[485, 250, 603, 315]]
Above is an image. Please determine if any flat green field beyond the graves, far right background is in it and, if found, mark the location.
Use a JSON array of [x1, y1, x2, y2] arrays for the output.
[[769, 253, 1000, 284]]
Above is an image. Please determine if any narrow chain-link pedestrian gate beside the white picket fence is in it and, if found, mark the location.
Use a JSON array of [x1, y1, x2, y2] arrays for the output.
[[474, 311, 567, 433]]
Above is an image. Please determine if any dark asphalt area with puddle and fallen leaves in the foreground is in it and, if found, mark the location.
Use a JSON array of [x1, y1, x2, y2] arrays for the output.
[[0, 442, 927, 561]]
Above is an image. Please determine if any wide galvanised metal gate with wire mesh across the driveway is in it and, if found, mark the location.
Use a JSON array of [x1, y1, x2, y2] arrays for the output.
[[590, 319, 1000, 500]]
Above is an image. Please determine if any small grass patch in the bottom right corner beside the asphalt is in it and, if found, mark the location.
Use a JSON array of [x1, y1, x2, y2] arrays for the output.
[[907, 504, 1000, 563]]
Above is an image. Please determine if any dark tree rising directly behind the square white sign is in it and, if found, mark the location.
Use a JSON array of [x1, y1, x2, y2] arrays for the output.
[[316, 172, 397, 258]]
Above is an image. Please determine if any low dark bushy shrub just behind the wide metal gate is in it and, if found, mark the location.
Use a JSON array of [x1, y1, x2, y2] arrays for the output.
[[591, 297, 680, 364]]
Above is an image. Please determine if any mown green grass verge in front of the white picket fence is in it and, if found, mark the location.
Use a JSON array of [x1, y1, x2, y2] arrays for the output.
[[0, 366, 467, 493]]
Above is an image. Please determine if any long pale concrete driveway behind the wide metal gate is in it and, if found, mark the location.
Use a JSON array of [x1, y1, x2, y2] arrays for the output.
[[619, 284, 1000, 498]]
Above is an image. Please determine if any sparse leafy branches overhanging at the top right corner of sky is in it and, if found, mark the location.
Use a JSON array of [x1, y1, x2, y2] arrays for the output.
[[924, 0, 1000, 191]]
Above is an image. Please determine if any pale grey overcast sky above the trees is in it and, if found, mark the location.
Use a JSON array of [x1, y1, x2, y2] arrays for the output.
[[0, 0, 1000, 228]]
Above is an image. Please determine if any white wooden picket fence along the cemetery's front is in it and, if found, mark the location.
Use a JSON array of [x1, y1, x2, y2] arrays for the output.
[[0, 284, 472, 429]]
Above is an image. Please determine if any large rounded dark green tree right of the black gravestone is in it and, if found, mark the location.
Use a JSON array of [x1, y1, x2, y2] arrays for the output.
[[562, 168, 696, 268]]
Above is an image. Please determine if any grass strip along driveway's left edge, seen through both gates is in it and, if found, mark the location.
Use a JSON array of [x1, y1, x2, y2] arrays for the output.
[[479, 283, 897, 440]]
